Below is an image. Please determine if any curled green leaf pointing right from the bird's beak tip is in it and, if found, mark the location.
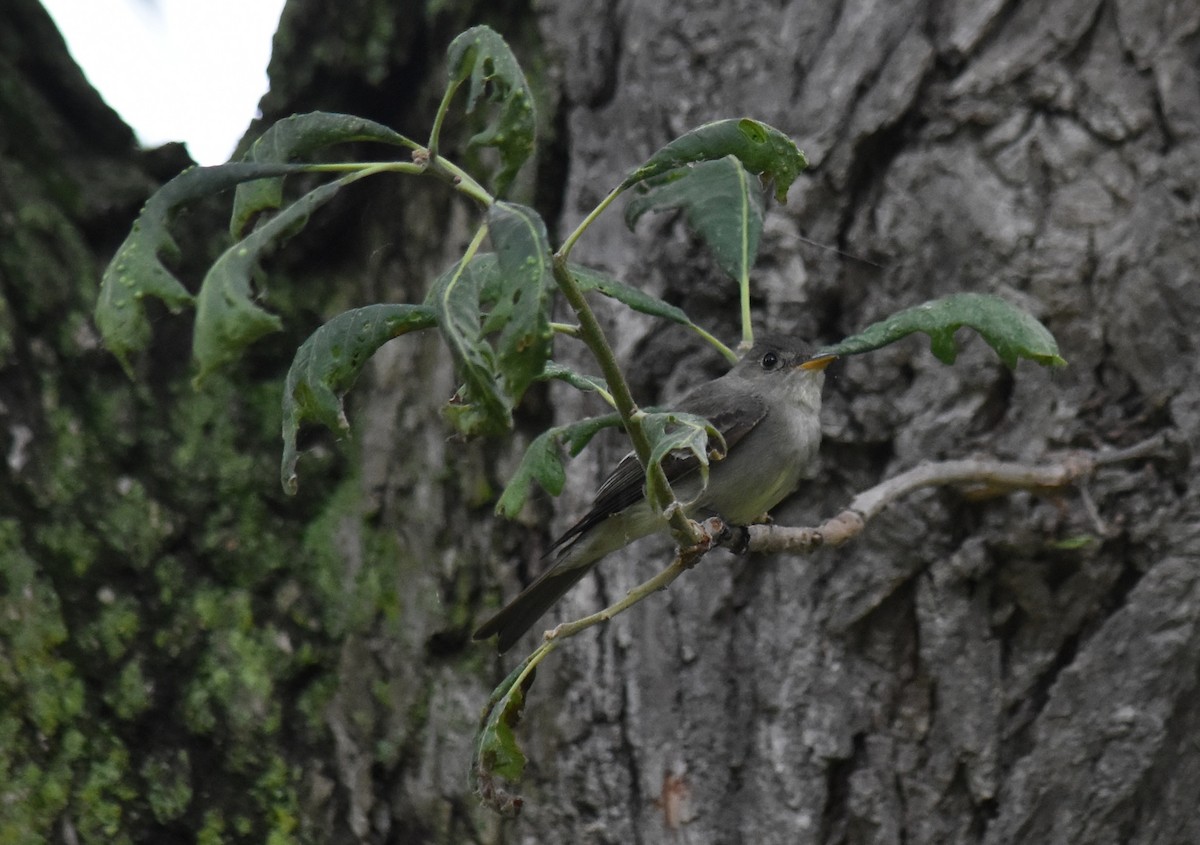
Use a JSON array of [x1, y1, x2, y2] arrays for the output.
[[812, 293, 1067, 367]]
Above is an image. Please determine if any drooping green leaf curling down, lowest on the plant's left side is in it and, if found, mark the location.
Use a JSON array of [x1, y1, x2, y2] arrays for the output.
[[280, 305, 437, 495]]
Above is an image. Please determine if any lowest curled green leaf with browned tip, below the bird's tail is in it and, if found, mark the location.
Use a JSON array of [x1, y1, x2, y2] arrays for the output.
[[472, 655, 534, 814]]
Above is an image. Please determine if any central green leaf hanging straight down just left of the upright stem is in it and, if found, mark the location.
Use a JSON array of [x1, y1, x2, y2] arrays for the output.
[[487, 202, 554, 404]]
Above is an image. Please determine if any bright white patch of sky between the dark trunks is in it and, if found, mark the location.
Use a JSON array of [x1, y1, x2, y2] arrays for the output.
[[42, 0, 283, 164]]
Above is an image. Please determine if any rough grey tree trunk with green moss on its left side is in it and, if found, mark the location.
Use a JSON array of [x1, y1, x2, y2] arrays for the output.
[[0, 0, 1200, 844]]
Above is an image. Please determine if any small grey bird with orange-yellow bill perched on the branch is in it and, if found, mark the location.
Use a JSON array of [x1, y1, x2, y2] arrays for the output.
[[475, 337, 834, 653]]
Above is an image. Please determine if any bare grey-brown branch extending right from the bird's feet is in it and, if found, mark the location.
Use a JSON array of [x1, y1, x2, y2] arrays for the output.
[[719, 433, 1168, 555]]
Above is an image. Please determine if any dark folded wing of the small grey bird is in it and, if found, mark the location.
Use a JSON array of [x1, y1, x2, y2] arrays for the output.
[[547, 385, 767, 553]]
